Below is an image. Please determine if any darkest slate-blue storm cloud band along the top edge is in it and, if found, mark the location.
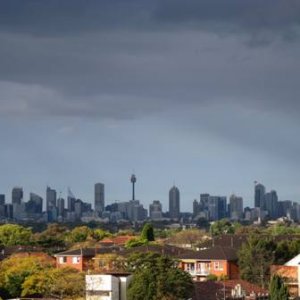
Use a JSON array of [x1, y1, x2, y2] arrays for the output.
[[0, 0, 300, 37]]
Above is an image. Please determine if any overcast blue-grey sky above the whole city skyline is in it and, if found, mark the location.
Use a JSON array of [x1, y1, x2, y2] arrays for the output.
[[0, 0, 300, 211]]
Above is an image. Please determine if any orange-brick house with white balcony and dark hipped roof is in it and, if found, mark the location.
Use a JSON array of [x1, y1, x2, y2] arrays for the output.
[[178, 246, 239, 281]]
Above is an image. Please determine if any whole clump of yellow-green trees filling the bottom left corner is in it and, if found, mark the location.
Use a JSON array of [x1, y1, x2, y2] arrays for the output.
[[0, 255, 85, 299]]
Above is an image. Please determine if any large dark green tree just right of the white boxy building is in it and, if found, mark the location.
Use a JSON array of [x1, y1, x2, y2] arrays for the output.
[[127, 252, 194, 300]]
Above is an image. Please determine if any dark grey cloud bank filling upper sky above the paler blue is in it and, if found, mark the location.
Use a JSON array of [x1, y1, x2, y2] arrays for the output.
[[0, 0, 300, 164]]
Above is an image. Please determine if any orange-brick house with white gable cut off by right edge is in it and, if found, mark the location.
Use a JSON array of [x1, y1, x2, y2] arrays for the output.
[[271, 254, 300, 297]]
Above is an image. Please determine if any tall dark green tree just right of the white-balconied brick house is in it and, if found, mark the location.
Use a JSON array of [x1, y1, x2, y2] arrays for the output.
[[238, 235, 275, 287]]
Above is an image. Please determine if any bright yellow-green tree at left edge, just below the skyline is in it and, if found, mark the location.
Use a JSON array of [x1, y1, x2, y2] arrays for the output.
[[0, 224, 32, 246]]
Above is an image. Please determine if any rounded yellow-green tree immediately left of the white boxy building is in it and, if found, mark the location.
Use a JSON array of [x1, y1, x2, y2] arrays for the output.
[[22, 267, 85, 299]]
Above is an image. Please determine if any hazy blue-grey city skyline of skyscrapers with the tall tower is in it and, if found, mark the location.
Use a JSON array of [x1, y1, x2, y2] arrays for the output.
[[0, 175, 300, 222]]
